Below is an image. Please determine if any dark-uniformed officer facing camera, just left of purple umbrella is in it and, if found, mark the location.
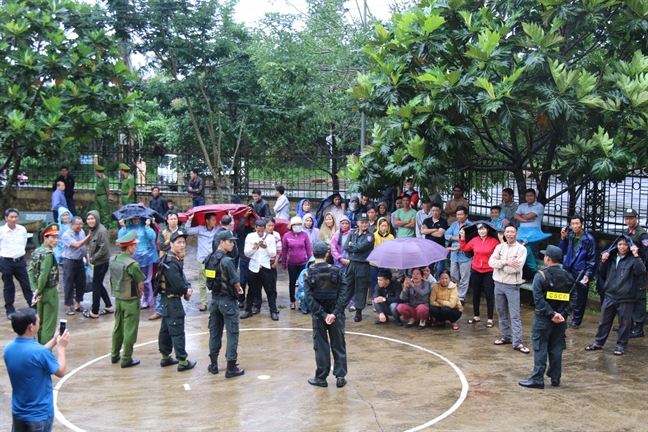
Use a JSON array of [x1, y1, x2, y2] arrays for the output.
[[344, 212, 374, 322]]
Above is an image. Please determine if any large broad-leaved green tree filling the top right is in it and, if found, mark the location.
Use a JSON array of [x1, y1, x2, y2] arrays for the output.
[[350, 0, 648, 208]]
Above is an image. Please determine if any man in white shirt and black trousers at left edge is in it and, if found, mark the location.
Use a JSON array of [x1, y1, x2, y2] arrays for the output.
[[0, 208, 33, 319]]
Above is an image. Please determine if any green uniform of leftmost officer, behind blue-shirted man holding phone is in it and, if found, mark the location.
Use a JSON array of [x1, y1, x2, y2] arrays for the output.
[[27, 244, 58, 345]]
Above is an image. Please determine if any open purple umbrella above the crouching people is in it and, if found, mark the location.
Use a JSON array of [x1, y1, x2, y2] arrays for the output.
[[367, 238, 448, 270]]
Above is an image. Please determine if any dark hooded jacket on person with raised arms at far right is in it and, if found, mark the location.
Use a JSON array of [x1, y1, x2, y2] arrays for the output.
[[600, 235, 646, 303]]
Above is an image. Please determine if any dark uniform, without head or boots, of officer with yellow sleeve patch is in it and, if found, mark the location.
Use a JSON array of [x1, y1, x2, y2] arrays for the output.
[[209, 252, 240, 362]]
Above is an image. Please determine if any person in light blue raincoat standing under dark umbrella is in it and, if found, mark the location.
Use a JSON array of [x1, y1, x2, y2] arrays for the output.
[[117, 215, 157, 309]]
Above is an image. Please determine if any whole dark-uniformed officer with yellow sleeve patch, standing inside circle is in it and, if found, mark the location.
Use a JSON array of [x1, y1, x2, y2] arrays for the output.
[[205, 230, 245, 378]]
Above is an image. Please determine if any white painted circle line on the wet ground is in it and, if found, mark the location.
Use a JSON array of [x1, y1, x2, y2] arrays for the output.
[[53, 328, 468, 432]]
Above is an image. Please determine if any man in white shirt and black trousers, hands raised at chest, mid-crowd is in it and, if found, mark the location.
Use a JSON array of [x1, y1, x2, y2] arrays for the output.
[[241, 219, 279, 321]]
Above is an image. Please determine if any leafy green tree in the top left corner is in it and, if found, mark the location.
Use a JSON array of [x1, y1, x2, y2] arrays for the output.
[[0, 0, 138, 206]]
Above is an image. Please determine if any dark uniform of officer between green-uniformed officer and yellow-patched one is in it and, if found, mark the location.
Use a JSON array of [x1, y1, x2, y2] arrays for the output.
[[158, 251, 191, 360]]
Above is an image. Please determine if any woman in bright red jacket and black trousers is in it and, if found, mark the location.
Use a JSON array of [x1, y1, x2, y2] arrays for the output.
[[459, 223, 500, 328]]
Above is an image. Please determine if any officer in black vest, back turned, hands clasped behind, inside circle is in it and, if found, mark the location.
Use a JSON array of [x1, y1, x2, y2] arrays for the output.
[[304, 240, 352, 388]]
